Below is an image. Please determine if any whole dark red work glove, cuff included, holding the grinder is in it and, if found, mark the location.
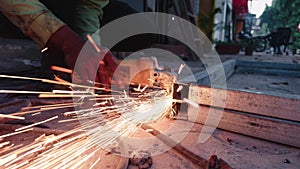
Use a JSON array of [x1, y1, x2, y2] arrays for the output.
[[45, 26, 118, 87]]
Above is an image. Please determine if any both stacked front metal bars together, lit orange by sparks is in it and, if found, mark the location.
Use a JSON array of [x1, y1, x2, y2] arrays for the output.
[[188, 86, 300, 148]]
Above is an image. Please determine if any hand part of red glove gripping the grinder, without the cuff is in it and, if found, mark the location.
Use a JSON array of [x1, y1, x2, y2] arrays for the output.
[[65, 42, 120, 88]]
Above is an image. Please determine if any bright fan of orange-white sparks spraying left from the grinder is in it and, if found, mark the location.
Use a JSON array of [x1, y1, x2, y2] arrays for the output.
[[0, 75, 174, 168]]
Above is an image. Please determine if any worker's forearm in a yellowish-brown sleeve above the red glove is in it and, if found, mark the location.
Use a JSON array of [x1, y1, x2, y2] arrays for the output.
[[0, 0, 65, 47]]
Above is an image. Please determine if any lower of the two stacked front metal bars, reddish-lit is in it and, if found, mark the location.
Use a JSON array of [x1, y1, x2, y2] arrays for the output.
[[188, 106, 300, 148]]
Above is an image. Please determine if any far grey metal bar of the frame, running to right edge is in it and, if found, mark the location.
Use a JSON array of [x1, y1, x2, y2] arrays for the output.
[[236, 60, 300, 71]]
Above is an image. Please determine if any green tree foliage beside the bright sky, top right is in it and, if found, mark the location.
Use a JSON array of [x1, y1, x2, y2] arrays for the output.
[[260, 0, 300, 49]]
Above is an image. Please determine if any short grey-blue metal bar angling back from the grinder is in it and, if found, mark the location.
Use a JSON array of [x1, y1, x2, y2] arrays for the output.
[[178, 60, 236, 85]]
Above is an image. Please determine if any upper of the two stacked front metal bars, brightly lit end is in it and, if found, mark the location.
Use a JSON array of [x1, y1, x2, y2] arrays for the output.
[[188, 86, 300, 122]]
